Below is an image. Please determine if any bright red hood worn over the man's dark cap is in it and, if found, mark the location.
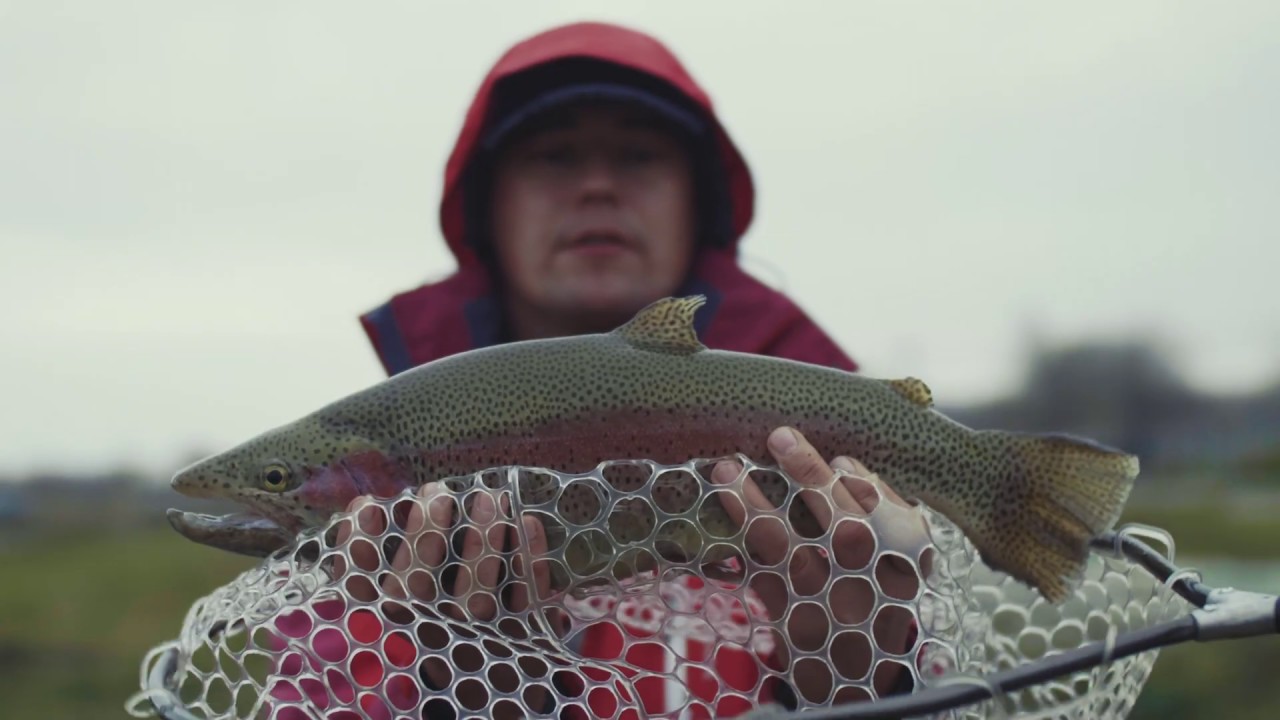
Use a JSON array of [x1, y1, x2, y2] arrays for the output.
[[440, 23, 755, 268]]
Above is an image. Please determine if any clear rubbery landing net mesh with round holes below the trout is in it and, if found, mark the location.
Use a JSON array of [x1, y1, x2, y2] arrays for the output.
[[128, 457, 1190, 720]]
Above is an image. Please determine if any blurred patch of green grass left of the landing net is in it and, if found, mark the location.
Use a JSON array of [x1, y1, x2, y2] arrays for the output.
[[0, 527, 251, 719]]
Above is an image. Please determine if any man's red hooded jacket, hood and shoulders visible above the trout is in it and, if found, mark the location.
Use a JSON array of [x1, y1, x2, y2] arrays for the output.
[[360, 23, 856, 374]]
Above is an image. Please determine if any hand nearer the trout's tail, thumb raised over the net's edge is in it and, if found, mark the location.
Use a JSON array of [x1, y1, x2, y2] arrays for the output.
[[712, 428, 929, 702]]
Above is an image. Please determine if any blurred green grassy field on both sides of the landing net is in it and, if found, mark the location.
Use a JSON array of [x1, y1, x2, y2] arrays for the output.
[[0, 511, 1280, 720]]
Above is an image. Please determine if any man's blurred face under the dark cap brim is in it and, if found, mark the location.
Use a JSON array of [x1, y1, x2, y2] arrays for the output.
[[490, 105, 695, 322]]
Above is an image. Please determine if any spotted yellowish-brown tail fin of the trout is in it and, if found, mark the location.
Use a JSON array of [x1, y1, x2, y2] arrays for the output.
[[970, 433, 1138, 603]]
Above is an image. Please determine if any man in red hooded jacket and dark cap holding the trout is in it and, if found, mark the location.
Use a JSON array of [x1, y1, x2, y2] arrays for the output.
[[335, 22, 918, 716]]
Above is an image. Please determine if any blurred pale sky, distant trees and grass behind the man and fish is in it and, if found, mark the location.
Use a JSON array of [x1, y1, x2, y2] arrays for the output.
[[0, 0, 1280, 717]]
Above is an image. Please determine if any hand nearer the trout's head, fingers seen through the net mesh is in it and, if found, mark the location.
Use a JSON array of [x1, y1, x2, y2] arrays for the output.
[[337, 483, 563, 717]]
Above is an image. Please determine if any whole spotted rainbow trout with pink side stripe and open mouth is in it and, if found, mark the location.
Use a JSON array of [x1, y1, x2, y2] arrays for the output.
[[170, 296, 1138, 602]]
